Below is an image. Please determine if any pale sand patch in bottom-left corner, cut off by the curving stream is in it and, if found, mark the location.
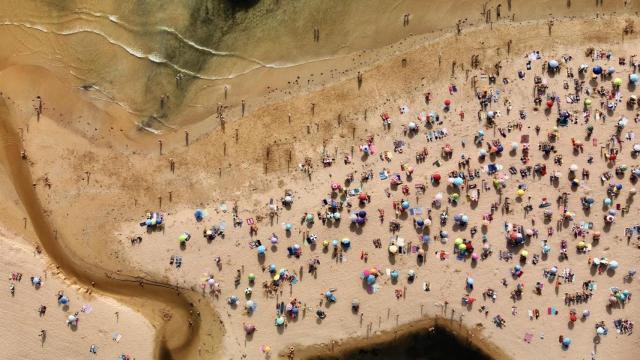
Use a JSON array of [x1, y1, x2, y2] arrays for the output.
[[0, 229, 154, 359]]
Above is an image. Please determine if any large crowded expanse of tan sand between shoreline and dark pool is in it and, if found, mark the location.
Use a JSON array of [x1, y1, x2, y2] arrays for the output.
[[0, 1, 639, 359]]
